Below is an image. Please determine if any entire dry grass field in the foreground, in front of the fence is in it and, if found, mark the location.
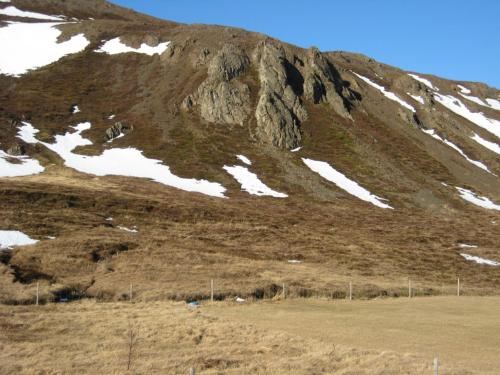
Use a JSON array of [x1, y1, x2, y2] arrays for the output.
[[0, 297, 500, 374]]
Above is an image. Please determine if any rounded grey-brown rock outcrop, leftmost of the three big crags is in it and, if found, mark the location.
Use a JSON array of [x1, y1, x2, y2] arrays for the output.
[[182, 44, 251, 125]]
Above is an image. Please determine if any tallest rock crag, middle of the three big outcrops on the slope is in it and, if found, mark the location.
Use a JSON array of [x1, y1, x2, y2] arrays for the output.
[[254, 41, 307, 149]]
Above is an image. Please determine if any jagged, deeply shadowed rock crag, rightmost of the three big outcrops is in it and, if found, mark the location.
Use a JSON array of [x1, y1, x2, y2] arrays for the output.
[[304, 48, 356, 120]]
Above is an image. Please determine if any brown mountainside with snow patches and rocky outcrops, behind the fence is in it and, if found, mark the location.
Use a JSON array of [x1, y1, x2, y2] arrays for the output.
[[0, 0, 500, 303]]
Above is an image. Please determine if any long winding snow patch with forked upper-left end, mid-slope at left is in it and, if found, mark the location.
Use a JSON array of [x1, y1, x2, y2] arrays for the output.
[[18, 122, 226, 198]]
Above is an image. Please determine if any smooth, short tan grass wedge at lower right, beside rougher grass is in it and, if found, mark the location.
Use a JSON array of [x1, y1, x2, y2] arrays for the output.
[[209, 297, 500, 375]]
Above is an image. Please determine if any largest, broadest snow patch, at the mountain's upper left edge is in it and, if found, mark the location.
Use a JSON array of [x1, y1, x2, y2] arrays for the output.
[[0, 23, 90, 76]]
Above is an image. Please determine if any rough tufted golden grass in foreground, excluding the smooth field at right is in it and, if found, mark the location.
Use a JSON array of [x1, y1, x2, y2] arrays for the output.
[[0, 300, 484, 375]]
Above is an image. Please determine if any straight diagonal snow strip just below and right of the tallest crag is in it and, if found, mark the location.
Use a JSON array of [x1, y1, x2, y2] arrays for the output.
[[302, 158, 393, 209]]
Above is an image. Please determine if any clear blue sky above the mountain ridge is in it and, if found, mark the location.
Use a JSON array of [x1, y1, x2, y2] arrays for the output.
[[112, 0, 500, 88]]
